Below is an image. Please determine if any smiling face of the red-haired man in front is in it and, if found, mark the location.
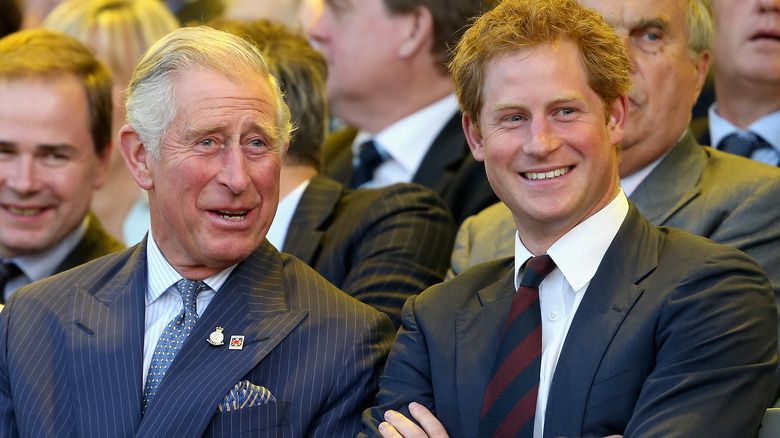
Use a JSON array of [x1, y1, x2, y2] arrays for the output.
[[464, 41, 626, 246]]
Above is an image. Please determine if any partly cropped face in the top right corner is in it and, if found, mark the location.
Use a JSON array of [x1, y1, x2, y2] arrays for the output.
[[712, 0, 780, 86]]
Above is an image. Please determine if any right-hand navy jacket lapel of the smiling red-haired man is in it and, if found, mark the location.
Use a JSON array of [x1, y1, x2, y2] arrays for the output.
[[544, 205, 658, 437]]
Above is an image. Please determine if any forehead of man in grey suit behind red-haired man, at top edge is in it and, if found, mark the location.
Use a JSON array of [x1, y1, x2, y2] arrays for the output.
[[582, 0, 688, 31]]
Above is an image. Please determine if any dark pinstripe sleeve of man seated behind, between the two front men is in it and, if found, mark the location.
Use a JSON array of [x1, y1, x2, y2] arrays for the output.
[[341, 184, 456, 327]]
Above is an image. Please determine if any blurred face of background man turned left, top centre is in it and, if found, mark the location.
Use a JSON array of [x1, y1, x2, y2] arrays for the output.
[[309, 0, 404, 119]]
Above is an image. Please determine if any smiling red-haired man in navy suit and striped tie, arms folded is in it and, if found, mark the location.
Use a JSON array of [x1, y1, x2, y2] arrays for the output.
[[364, 0, 777, 438]]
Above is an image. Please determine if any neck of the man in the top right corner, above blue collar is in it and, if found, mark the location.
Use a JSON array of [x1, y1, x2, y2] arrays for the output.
[[715, 73, 780, 129]]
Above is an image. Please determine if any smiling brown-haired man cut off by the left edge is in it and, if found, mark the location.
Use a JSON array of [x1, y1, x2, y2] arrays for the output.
[[0, 30, 124, 303]]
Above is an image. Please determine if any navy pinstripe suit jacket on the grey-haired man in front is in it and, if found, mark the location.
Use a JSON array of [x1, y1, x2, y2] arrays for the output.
[[0, 240, 393, 438]]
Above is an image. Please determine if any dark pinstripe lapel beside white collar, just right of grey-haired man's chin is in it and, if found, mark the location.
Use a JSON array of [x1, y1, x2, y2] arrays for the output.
[[283, 175, 343, 266]]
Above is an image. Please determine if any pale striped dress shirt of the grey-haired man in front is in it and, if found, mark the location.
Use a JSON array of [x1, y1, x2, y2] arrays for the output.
[[141, 231, 236, 384]]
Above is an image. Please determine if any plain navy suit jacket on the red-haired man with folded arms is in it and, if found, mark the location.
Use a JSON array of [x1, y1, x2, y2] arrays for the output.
[[364, 204, 777, 438]]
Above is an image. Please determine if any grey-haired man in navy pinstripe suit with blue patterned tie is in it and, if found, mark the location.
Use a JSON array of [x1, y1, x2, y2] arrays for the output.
[[0, 28, 393, 437]]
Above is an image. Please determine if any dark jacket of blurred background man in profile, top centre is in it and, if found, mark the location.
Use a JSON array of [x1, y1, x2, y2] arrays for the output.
[[323, 113, 498, 224]]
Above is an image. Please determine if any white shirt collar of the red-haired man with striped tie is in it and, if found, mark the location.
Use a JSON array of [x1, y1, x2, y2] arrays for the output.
[[515, 189, 628, 291]]
